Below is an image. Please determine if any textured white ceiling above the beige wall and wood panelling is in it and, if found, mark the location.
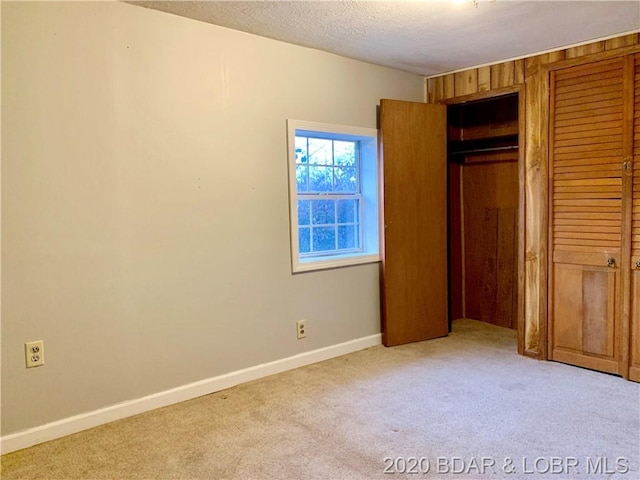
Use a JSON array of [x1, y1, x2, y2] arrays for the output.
[[128, 0, 640, 76]]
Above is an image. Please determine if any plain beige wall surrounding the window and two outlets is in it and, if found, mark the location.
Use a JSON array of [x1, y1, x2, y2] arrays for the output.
[[2, 2, 424, 435]]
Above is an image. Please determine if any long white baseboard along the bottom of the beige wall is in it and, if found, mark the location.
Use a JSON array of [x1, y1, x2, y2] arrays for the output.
[[0, 334, 382, 454]]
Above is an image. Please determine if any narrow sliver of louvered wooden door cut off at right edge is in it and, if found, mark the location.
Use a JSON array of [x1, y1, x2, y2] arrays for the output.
[[629, 55, 640, 382]]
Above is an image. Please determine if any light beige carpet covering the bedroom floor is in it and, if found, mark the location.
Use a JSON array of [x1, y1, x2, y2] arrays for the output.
[[2, 320, 640, 480]]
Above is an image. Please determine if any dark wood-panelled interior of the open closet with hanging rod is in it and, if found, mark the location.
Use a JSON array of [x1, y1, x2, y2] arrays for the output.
[[447, 92, 520, 329]]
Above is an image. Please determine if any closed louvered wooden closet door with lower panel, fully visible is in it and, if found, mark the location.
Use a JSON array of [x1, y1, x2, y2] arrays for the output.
[[549, 58, 631, 374]]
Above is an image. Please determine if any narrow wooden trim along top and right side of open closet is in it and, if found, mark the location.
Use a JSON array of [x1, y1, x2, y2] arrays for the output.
[[438, 84, 524, 357]]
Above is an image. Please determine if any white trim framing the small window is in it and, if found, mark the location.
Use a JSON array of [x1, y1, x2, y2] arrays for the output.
[[287, 119, 381, 273]]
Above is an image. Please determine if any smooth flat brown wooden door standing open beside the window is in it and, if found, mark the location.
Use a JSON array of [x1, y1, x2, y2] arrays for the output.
[[380, 100, 449, 346]]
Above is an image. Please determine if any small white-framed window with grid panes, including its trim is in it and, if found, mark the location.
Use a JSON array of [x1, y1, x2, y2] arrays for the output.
[[287, 120, 380, 272]]
